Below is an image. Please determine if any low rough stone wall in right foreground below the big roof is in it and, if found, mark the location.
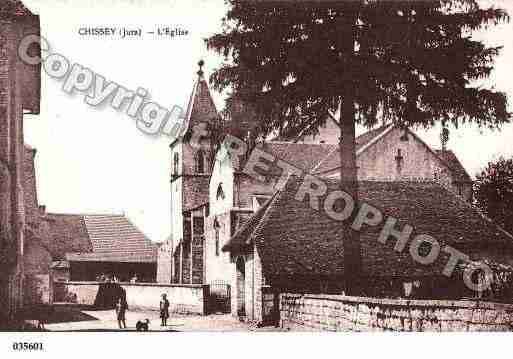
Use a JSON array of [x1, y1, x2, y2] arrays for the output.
[[280, 294, 513, 332]]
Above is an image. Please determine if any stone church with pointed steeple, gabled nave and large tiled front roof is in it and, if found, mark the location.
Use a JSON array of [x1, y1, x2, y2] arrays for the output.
[[157, 62, 513, 322]]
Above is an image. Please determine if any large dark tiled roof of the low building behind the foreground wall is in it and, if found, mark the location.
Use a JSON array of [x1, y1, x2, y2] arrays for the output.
[[223, 180, 513, 276]]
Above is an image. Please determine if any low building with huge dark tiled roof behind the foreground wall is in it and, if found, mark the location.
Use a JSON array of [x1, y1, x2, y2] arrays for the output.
[[222, 179, 513, 321]]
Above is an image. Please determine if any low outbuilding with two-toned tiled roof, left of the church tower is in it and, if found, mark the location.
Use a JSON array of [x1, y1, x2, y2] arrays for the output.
[[47, 213, 157, 282]]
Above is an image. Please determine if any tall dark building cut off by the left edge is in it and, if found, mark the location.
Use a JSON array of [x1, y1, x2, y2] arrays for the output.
[[0, 0, 41, 326]]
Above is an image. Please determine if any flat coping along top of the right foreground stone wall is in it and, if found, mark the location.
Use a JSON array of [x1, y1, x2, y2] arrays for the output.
[[282, 293, 513, 311]]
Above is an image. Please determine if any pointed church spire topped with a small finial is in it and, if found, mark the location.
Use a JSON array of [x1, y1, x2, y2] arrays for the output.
[[182, 60, 218, 135]]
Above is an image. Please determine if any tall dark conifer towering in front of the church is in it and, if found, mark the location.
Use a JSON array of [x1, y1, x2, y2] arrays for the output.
[[207, 0, 510, 291]]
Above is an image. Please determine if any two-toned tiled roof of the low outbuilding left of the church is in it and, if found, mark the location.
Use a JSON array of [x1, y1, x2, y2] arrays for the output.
[[47, 214, 157, 263]]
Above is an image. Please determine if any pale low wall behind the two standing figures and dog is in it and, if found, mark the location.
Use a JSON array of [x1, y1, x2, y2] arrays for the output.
[[54, 282, 209, 315]]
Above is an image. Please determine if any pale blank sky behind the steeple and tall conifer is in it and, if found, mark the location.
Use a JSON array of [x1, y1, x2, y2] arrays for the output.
[[24, 0, 513, 242]]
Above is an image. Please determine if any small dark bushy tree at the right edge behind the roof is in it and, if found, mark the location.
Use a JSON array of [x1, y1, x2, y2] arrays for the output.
[[474, 157, 513, 233]]
